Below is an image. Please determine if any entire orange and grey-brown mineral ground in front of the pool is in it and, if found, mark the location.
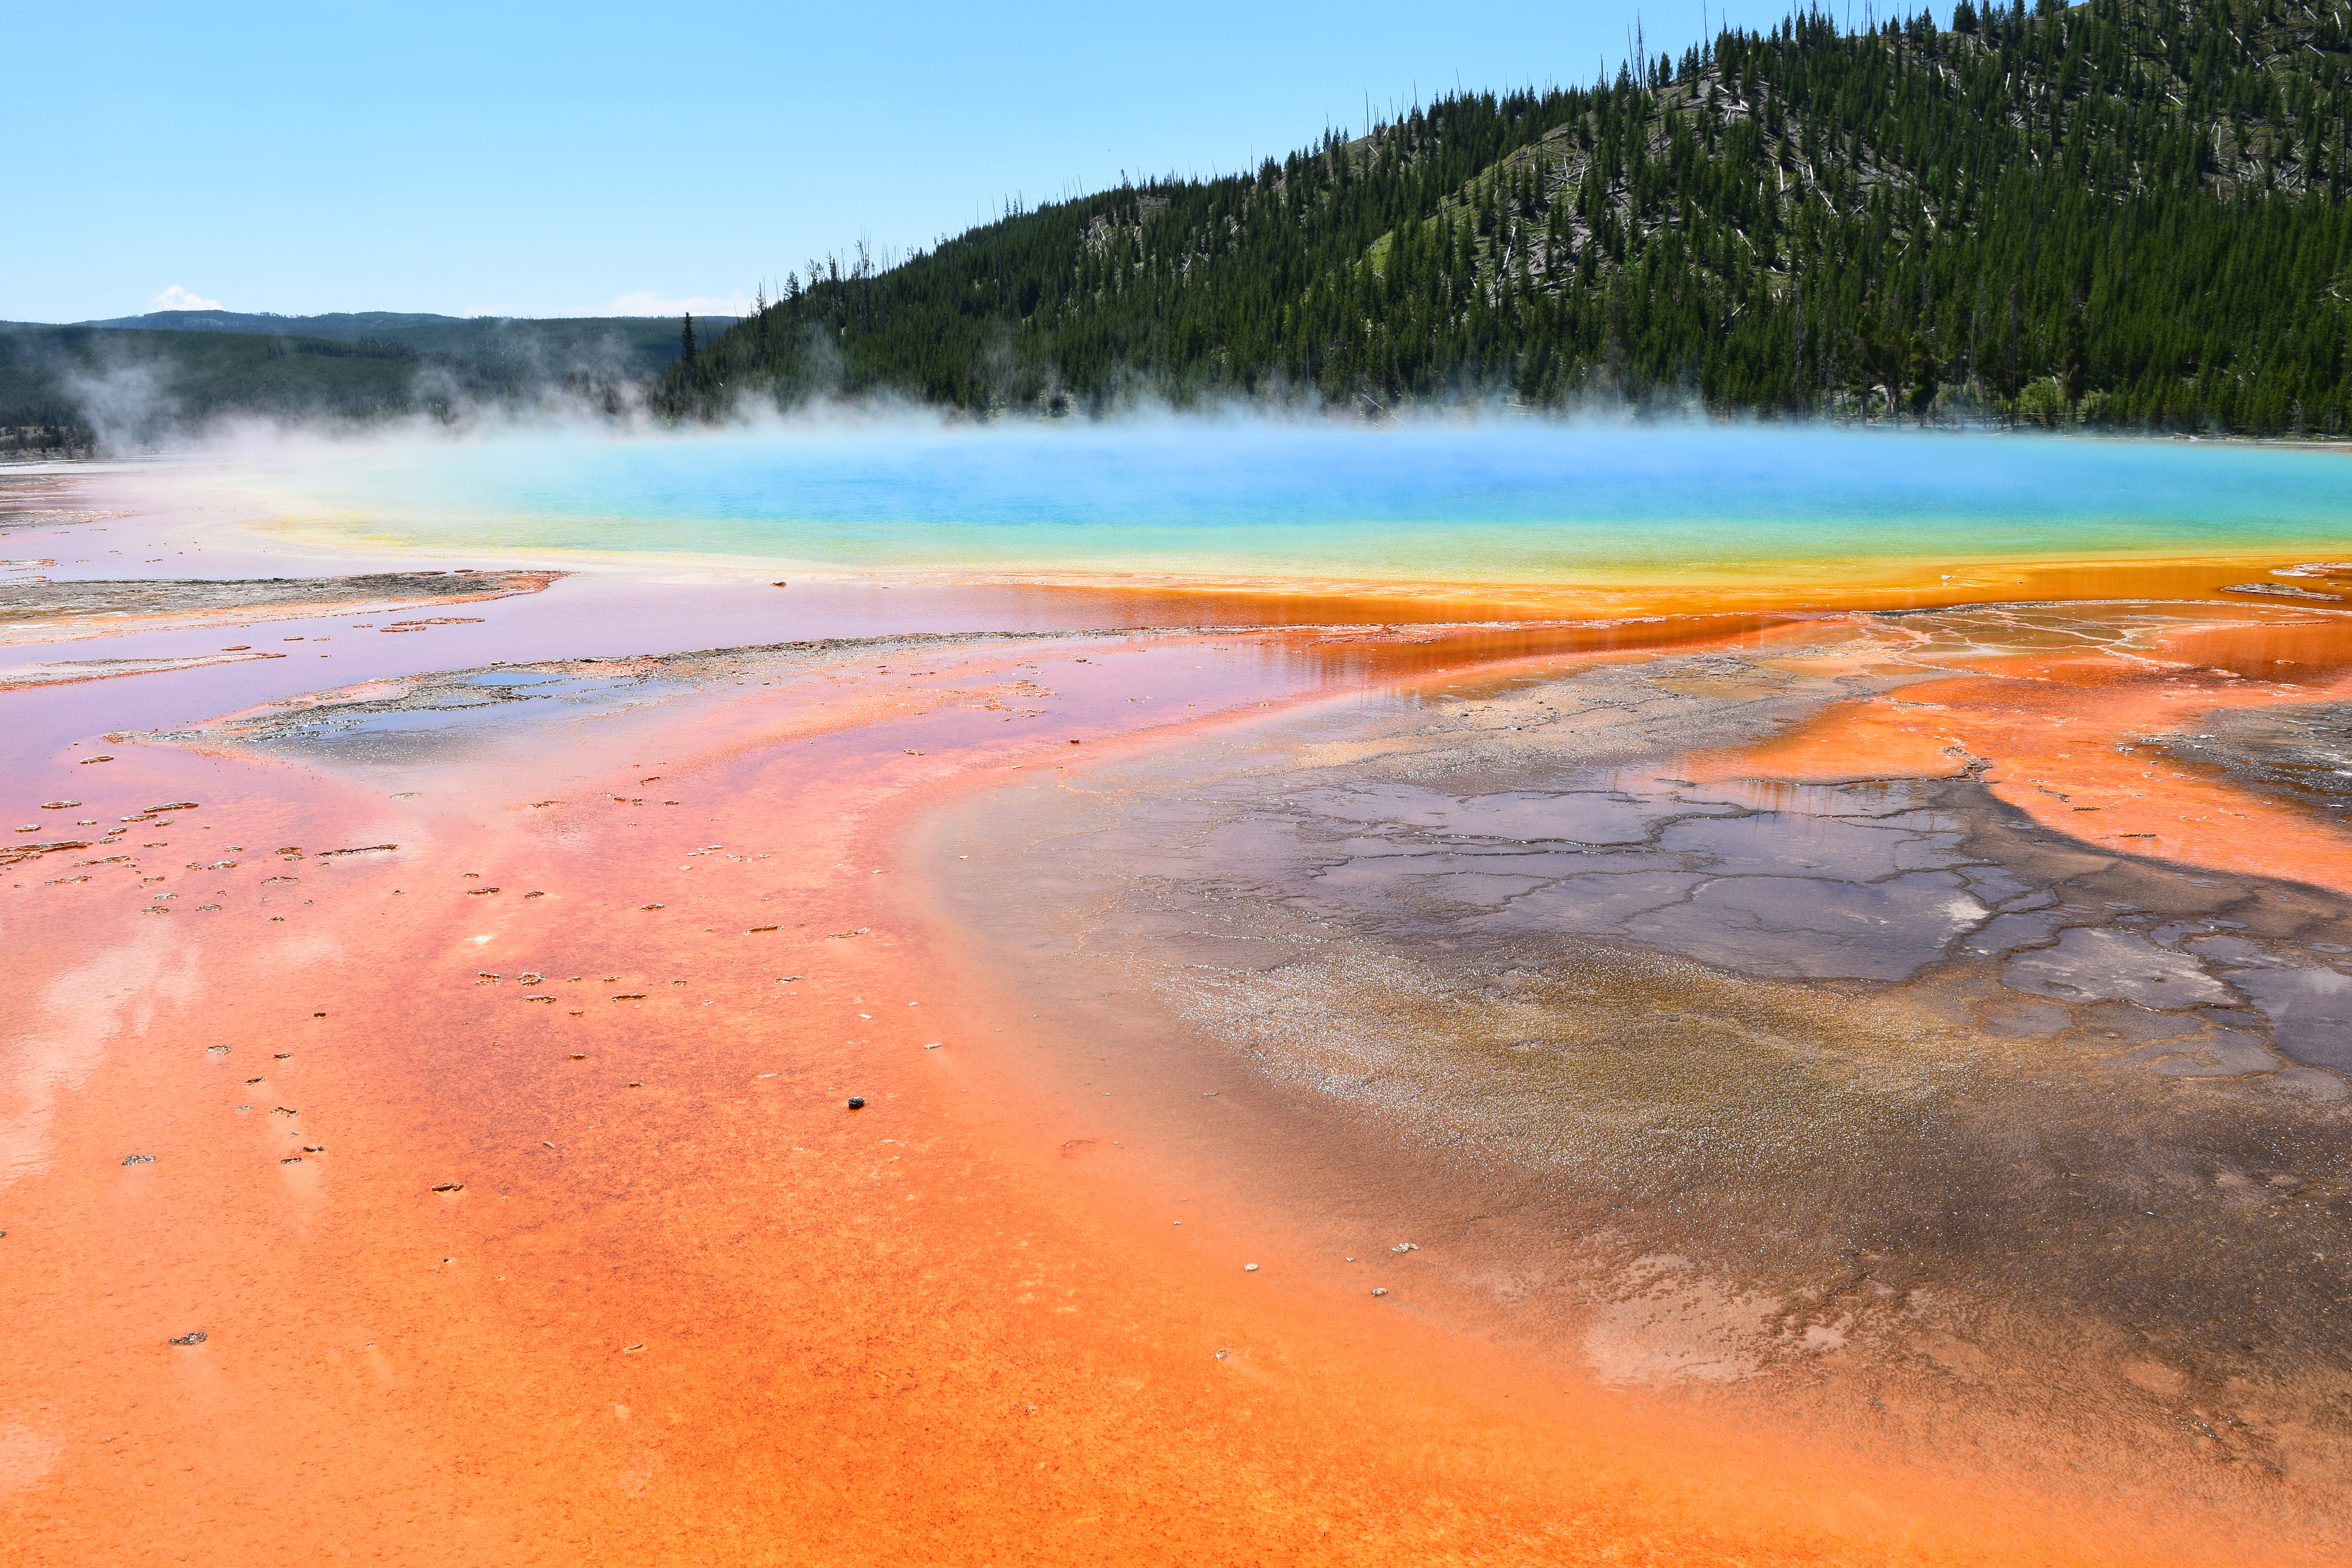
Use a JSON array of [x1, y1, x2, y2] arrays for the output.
[[0, 451, 2352, 1563]]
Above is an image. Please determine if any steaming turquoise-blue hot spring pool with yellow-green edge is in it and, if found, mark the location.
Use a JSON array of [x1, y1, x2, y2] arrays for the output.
[[258, 421, 2352, 583]]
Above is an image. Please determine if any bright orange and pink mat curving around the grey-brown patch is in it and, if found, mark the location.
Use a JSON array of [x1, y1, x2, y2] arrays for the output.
[[7, 616, 2060, 1563]]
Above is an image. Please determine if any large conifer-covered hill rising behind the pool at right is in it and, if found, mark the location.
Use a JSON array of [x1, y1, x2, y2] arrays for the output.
[[656, 0, 2352, 432]]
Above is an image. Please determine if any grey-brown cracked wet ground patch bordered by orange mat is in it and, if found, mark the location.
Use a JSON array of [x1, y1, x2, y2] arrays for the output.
[[931, 611, 2352, 1519]]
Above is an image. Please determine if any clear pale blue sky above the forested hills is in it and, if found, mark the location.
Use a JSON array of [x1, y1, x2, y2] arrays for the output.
[[0, 0, 1797, 322]]
